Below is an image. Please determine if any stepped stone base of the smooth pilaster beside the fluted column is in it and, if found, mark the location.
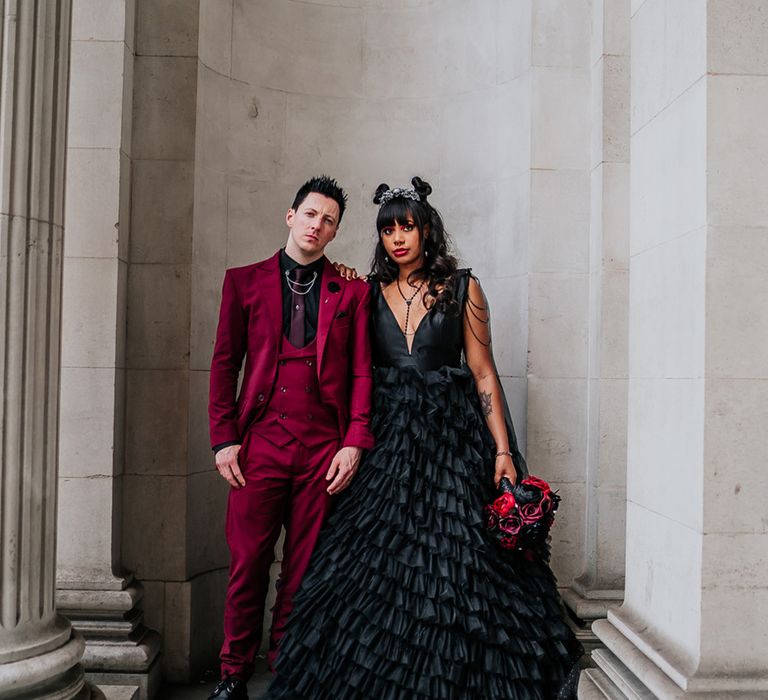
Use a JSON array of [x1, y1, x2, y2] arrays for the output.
[[56, 576, 161, 700]]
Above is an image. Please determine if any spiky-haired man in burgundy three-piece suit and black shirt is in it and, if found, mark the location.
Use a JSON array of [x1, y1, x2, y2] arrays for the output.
[[204, 176, 373, 700]]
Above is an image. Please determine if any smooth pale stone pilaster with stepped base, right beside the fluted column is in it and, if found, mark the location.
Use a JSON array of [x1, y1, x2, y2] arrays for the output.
[[56, 0, 160, 699]]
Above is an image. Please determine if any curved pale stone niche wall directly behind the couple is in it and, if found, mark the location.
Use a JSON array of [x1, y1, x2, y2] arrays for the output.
[[189, 0, 544, 660]]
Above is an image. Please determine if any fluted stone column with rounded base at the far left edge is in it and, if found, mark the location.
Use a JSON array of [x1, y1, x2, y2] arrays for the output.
[[0, 0, 90, 698]]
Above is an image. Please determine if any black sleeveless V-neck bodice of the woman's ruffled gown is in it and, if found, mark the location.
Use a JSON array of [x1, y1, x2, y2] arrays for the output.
[[371, 269, 470, 371]]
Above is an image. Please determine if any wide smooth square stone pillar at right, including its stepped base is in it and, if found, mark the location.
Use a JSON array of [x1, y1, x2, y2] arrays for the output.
[[581, 0, 768, 700]]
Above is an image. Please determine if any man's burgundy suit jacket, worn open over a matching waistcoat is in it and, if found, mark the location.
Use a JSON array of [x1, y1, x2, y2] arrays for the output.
[[208, 253, 373, 448]]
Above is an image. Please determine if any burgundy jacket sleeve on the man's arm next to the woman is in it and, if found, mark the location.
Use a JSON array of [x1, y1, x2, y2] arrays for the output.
[[342, 284, 374, 449]]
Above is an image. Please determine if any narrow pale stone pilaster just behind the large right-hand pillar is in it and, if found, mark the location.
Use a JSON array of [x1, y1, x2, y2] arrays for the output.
[[563, 0, 629, 649]]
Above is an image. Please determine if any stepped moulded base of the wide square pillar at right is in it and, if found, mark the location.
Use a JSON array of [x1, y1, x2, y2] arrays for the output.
[[592, 610, 768, 700]]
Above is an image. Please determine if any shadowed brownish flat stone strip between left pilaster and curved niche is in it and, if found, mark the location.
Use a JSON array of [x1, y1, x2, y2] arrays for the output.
[[123, 0, 202, 680]]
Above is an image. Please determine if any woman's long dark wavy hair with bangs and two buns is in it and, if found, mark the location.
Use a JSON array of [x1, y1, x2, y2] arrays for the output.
[[371, 177, 459, 313]]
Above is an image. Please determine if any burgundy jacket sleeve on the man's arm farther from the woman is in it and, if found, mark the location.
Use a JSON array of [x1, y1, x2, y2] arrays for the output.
[[208, 270, 248, 446]]
